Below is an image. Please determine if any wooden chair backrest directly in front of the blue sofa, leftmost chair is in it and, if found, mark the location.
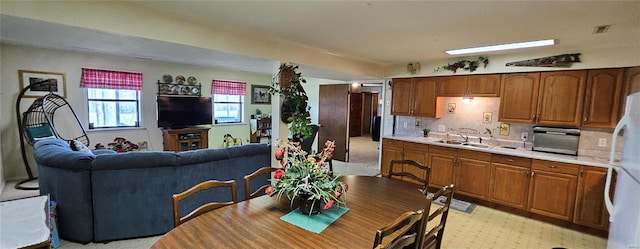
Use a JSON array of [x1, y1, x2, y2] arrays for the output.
[[173, 180, 238, 227]]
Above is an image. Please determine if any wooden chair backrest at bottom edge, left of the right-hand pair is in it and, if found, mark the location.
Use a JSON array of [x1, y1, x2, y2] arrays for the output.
[[373, 209, 424, 248]]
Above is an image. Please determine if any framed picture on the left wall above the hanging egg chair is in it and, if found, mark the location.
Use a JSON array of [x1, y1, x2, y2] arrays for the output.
[[18, 70, 67, 98]]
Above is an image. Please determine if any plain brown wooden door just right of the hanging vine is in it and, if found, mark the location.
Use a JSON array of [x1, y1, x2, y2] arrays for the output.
[[318, 84, 351, 162]]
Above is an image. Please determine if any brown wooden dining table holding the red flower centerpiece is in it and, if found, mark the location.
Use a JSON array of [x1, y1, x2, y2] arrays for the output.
[[151, 176, 426, 249]]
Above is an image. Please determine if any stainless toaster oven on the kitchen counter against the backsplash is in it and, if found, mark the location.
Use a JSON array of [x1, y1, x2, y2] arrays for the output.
[[533, 126, 580, 156]]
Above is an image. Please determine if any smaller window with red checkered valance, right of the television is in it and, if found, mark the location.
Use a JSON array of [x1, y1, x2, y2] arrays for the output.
[[211, 80, 247, 124]]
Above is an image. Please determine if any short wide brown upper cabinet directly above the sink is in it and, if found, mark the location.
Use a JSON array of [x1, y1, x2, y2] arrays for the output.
[[435, 74, 500, 97]]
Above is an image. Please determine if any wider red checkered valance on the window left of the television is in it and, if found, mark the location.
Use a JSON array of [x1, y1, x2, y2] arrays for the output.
[[80, 68, 142, 91]]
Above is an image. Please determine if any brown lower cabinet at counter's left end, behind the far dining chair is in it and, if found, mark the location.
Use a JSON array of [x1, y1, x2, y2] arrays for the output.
[[380, 138, 429, 184]]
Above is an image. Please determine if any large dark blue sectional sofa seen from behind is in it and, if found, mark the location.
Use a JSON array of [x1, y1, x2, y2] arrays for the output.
[[34, 139, 271, 243]]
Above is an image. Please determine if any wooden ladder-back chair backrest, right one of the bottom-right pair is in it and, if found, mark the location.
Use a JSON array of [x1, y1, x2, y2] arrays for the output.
[[418, 184, 454, 249]]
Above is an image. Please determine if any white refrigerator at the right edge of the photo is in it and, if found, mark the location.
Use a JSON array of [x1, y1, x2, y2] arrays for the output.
[[605, 93, 640, 249]]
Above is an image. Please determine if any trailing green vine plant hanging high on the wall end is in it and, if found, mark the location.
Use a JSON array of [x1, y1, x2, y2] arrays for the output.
[[269, 64, 311, 140]]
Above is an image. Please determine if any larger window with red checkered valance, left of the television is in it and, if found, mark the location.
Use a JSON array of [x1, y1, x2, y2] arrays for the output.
[[80, 68, 142, 129]]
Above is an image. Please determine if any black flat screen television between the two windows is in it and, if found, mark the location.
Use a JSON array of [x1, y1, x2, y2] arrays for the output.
[[157, 96, 213, 129]]
